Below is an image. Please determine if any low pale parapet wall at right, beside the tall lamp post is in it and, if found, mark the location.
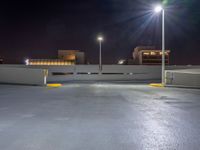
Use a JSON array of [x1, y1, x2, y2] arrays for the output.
[[165, 69, 200, 88]]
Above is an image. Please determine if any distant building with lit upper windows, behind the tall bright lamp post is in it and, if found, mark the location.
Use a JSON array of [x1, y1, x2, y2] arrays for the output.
[[133, 46, 170, 65]]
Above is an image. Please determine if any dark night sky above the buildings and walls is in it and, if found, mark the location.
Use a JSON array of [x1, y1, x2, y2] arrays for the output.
[[0, 0, 200, 64]]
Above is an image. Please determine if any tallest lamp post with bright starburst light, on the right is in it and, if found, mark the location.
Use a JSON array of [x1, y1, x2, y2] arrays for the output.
[[154, 5, 165, 85]]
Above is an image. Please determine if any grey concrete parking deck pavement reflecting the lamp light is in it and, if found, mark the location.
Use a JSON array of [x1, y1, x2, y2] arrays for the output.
[[0, 83, 200, 150]]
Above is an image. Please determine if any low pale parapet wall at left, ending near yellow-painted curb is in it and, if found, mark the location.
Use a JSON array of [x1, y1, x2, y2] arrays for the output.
[[0, 65, 48, 86]]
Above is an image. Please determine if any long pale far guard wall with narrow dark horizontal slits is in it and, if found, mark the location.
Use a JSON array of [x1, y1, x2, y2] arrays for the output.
[[46, 65, 200, 82]]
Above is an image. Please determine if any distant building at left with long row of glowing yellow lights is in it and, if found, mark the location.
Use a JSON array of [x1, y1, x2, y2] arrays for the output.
[[26, 50, 85, 66]]
